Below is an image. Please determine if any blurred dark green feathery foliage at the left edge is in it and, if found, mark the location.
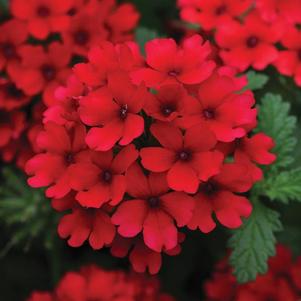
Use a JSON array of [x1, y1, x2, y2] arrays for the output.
[[0, 167, 57, 257]]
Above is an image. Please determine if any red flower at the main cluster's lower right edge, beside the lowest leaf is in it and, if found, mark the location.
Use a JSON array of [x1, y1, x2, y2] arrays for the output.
[[188, 163, 253, 233]]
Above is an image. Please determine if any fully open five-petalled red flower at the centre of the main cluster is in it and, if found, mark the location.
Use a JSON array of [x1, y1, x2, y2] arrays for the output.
[[141, 123, 223, 193]]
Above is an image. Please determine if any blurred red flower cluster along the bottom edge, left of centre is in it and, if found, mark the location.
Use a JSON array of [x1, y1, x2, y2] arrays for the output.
[[27, 266, 174, 301]]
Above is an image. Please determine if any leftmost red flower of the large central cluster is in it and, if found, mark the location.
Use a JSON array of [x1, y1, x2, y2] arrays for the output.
[[26, 122, 89, 198]]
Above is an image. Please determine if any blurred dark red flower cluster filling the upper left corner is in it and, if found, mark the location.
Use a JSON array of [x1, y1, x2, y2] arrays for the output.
[[0, 0, 139, 168]]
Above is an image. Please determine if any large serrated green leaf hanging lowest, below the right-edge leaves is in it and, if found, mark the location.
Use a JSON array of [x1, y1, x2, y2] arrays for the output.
[[229, 202, 282, 283]]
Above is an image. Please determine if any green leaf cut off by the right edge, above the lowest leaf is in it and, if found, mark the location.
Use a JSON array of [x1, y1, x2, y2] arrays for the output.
[[263, 168, 301, 203]]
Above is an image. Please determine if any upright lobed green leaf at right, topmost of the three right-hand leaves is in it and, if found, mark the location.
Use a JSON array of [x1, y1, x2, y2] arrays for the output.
[[257, 93, 297, 173]]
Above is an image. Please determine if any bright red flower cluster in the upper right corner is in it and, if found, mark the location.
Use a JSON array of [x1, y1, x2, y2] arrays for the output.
[[178, 0, 301, 86]]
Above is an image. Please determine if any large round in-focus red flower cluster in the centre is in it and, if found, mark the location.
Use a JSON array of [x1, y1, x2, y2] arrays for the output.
[[26, 35, 275, 273]]
